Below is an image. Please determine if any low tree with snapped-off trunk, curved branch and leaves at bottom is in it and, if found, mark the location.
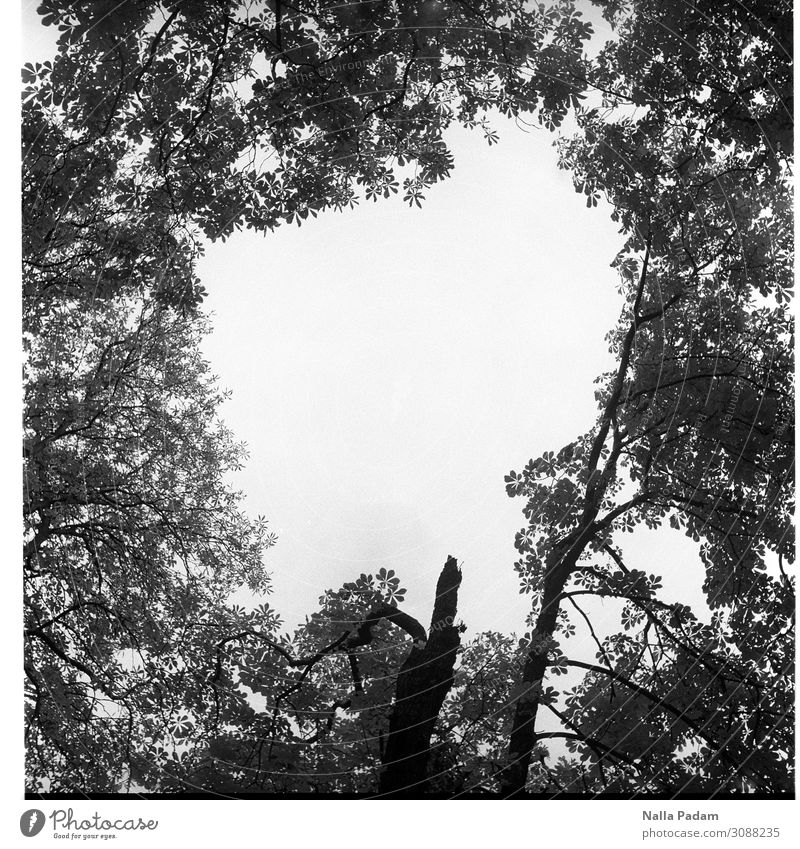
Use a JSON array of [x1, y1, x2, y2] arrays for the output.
[[158, 557, 462, 796]]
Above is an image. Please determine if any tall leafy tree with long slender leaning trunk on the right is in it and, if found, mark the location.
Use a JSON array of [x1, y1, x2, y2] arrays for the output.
[[496, 2, 794, 794]]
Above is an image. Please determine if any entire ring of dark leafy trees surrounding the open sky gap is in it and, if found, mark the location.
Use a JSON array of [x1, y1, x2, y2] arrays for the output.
[[22, 0, 794, 797]]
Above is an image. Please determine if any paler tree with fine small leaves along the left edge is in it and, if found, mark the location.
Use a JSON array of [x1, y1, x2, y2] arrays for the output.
[[24, 298, 276, 791]]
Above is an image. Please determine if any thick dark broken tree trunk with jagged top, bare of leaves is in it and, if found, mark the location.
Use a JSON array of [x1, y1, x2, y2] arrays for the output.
[[379, 557, 461, 796]]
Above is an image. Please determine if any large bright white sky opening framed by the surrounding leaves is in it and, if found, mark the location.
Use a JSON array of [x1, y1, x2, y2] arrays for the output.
[[200, 121, 620, 630]]
